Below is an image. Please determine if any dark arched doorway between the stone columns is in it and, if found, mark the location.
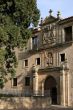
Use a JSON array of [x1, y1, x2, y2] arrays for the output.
[[44, 76, 57, 104]]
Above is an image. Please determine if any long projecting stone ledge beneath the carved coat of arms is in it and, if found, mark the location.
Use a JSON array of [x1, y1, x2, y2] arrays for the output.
[[29, 40, 73, 54]]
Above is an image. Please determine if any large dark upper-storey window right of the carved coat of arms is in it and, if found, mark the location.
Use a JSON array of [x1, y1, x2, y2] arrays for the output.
[[64, 26, 72, 42]]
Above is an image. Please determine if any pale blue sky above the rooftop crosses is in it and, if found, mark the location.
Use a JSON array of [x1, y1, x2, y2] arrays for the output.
[[37, 0, 73, 18]]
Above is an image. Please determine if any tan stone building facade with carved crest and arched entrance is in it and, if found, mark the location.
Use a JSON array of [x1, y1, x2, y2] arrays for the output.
[[3, 10, 73, 106]]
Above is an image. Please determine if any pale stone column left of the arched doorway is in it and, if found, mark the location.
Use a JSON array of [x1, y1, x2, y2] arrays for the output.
[[33, 66, 38, 96]]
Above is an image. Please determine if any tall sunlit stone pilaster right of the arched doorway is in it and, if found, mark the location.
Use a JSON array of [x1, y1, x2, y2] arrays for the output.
[[60, 61, 70, 106]]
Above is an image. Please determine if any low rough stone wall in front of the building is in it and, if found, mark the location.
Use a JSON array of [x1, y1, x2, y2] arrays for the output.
[[0, 97, 50, 110]]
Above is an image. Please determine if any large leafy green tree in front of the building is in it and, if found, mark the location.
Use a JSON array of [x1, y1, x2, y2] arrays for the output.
[[0, 0, 40, 87]]
